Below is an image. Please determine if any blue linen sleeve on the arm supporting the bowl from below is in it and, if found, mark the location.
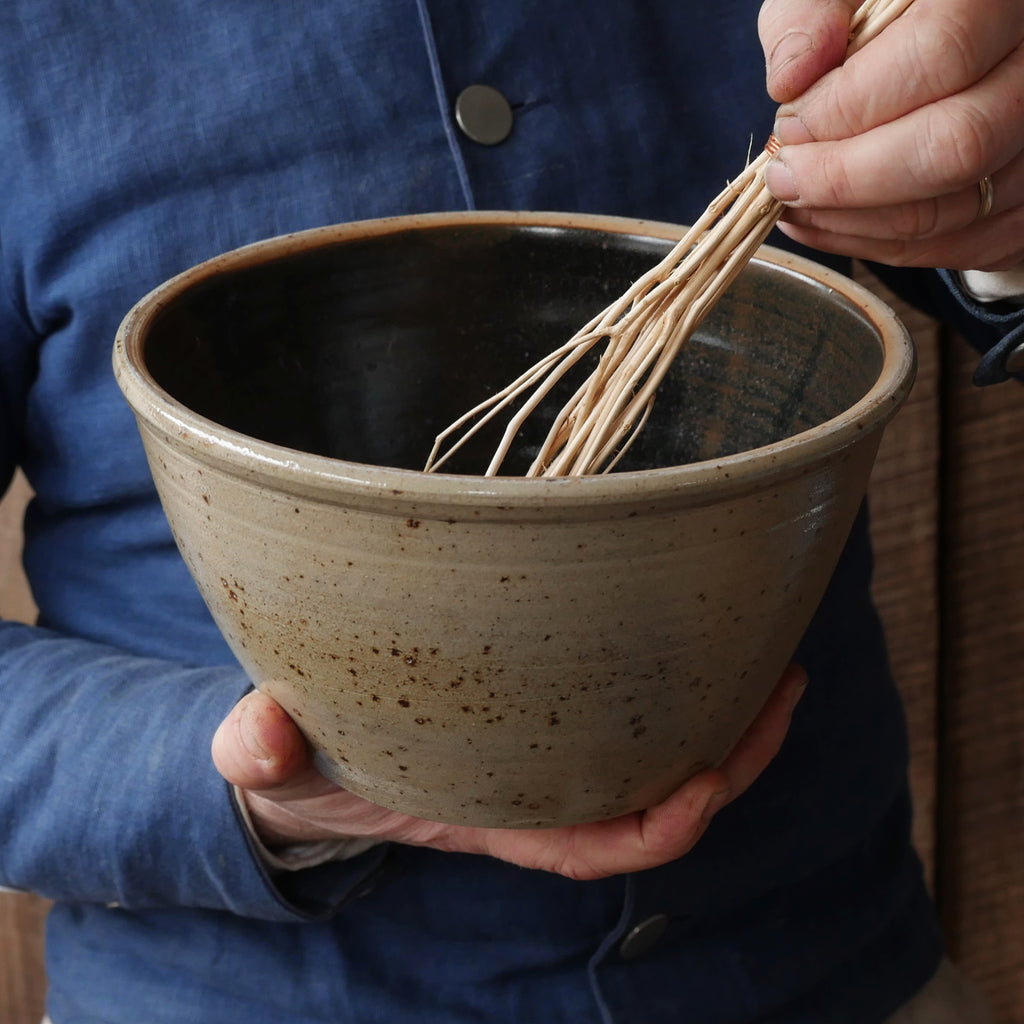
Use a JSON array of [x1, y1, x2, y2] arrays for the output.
[[0, 623, 387, 921]]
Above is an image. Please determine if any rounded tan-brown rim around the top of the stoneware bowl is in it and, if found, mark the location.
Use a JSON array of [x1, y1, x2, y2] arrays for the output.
[[113, 211, 916, 508]]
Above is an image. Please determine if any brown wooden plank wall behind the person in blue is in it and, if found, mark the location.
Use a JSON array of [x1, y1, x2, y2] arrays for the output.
[[0, 276, 1024, 1024]]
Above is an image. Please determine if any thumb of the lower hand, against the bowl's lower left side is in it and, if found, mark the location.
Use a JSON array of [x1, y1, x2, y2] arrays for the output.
[[211, 690, 311, 791]]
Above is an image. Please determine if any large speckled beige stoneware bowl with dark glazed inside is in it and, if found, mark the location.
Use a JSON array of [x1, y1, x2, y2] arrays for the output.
[[114, 213, 914, 827]]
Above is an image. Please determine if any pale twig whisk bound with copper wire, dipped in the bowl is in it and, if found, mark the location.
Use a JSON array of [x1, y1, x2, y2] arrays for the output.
[[425, 0, 911, 476]]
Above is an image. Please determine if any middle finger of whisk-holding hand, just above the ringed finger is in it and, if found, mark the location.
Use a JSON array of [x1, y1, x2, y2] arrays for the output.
[[765, 47, 1024, 209]]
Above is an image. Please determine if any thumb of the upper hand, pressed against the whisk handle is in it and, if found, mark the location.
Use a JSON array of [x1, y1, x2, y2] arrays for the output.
[[758, 0, 857, 103]]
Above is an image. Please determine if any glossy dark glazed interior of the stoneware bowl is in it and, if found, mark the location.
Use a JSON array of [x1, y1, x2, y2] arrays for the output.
[[143, 223, 883, 473]]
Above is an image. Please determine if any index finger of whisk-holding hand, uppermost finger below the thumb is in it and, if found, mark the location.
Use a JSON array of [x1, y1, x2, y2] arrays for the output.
[[775, 0, 1024, 144]]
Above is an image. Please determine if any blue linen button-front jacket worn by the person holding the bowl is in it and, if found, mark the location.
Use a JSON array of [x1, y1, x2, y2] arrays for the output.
[[0, 0, 1015, 1024]]
